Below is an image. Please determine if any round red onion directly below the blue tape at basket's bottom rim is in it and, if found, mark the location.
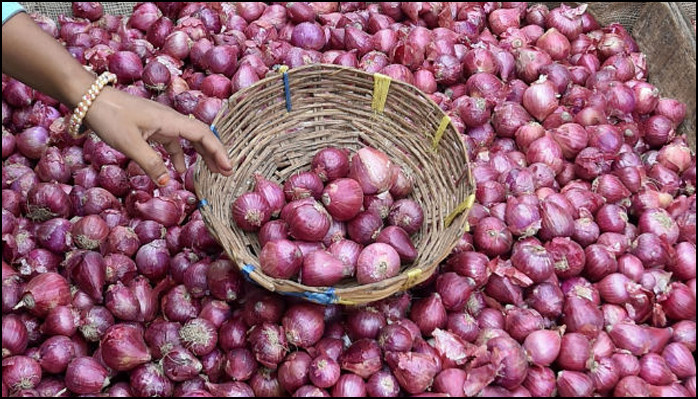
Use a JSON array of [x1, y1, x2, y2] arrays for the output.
[[281, 304, 325, 348]]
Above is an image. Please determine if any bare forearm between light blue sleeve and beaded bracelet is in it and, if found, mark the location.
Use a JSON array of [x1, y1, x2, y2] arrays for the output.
[[2, 13, 95, 108]]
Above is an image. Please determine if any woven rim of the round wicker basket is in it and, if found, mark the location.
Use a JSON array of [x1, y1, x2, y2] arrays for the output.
[[194, 64, 475, 305]]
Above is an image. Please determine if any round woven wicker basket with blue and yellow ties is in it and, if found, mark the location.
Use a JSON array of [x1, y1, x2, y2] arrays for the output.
[[194, 65, 474, 304]]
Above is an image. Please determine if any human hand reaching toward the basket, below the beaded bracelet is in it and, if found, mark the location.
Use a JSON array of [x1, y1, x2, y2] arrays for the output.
[[85, 87, 232, 185]]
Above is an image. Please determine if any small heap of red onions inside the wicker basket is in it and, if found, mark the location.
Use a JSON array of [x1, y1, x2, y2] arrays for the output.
[[231, 147, 424, 287]]
